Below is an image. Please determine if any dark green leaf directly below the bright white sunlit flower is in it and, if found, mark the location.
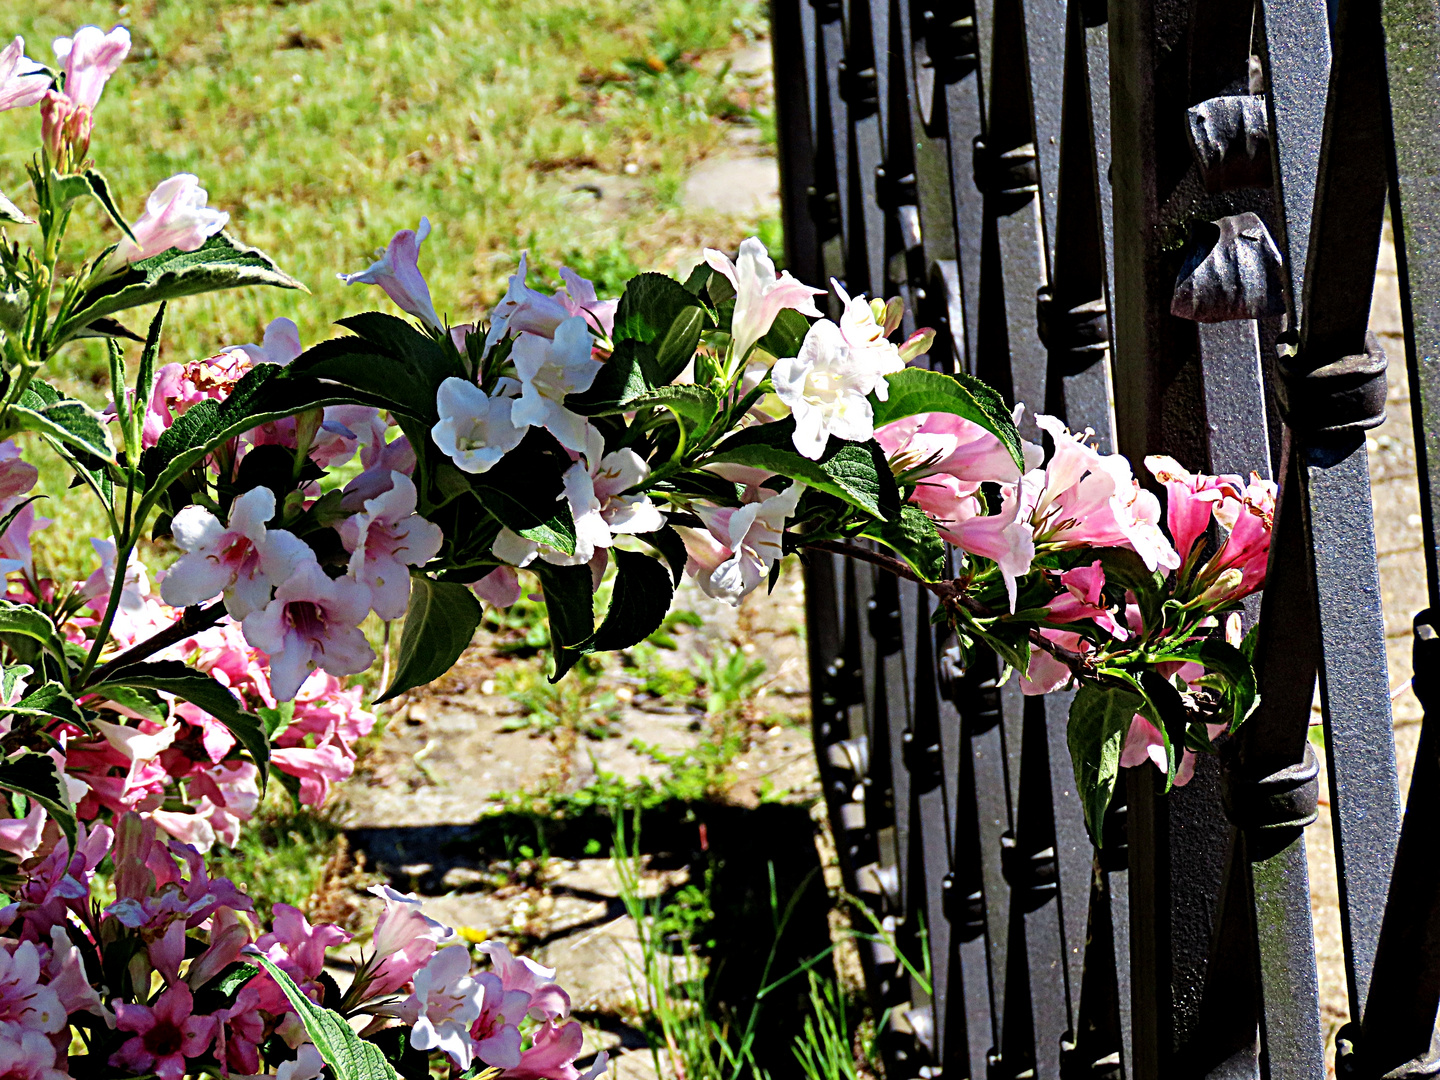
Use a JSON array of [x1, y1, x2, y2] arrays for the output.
[[706, 418, 900, 520]]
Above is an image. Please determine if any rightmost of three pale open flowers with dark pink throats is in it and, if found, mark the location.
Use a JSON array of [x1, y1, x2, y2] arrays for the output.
[[337, 472, 445, 619]]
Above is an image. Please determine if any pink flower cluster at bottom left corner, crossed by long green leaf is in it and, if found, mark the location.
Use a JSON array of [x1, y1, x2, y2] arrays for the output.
[[0, 814, 605, 1080]]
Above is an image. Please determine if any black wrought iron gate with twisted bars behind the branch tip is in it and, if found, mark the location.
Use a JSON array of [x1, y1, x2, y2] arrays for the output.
[[773, 0, 1440, 1080]]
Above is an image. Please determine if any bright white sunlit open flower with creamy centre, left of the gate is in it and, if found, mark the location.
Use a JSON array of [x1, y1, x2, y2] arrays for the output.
[[770, 320, 890, 459]]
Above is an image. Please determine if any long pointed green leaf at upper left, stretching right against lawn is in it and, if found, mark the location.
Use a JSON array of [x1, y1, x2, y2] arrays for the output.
[[55, 232, 305, 346]]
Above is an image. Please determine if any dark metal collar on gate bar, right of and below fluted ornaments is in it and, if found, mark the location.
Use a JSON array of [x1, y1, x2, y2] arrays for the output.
[[1277, 333, 1387, 436]]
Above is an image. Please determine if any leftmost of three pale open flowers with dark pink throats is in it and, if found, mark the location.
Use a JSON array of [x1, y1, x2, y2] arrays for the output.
[[160, 487, 314, 619]]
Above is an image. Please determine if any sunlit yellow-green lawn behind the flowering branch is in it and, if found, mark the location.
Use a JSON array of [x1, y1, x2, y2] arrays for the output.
[[0, 0, 773, 584]]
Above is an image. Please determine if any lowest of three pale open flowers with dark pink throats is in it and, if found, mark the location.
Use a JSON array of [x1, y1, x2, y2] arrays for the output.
[[243, 560, 374, 701]]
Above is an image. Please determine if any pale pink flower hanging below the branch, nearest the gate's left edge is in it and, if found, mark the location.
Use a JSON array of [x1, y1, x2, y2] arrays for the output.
[[675, 481, 805, 605]]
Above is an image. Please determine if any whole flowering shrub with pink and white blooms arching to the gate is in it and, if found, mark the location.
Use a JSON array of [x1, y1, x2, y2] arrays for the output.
[[0, 14, 1276, 1080]]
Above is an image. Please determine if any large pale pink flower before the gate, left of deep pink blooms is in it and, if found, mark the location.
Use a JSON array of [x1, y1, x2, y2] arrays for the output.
[[1022, 415, 1181, 570]]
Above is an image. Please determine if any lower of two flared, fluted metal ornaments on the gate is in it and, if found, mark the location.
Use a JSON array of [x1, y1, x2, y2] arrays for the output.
[[1171, 213, 1284, 323]]
